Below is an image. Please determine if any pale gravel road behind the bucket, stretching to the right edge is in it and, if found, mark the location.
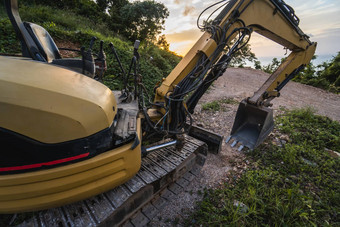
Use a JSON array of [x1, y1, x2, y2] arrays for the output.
[[201, 68, 340, 121]]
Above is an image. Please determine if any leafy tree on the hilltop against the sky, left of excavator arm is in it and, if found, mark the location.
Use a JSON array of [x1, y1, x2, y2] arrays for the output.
[[120, 0, 169, 41]]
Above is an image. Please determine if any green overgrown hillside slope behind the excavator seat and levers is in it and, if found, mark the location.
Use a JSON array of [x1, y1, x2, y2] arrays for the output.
[[0, 3, 181, 95]]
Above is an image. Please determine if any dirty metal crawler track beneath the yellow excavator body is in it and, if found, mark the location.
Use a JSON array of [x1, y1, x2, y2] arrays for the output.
[[15, 136, 208, 227]]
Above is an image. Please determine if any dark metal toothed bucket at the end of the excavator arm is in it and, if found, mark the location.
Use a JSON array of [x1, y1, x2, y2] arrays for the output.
[[227, 100, 274, 150]]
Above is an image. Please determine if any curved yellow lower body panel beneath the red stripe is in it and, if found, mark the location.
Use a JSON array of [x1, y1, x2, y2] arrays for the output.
[[0, 118, 141, 213]]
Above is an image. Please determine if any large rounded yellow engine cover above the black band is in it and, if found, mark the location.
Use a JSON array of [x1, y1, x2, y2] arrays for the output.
[[0, 56, 117, 143]]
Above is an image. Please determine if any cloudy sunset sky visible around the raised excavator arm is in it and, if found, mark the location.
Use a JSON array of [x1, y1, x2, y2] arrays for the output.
[[157, 0, 340, 57]]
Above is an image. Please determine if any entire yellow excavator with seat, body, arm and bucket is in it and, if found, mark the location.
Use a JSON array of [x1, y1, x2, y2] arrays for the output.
[[0, 0, 316, 223]]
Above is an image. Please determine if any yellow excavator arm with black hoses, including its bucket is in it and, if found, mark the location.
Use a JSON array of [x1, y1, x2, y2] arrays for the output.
[[148, 0, 316, 149]]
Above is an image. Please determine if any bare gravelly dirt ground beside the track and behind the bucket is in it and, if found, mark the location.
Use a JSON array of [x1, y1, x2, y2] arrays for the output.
[[149, 68, 340, 226]]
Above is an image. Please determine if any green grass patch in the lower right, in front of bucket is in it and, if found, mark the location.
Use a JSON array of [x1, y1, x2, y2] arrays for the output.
[[186, 109, 340, 226]]
